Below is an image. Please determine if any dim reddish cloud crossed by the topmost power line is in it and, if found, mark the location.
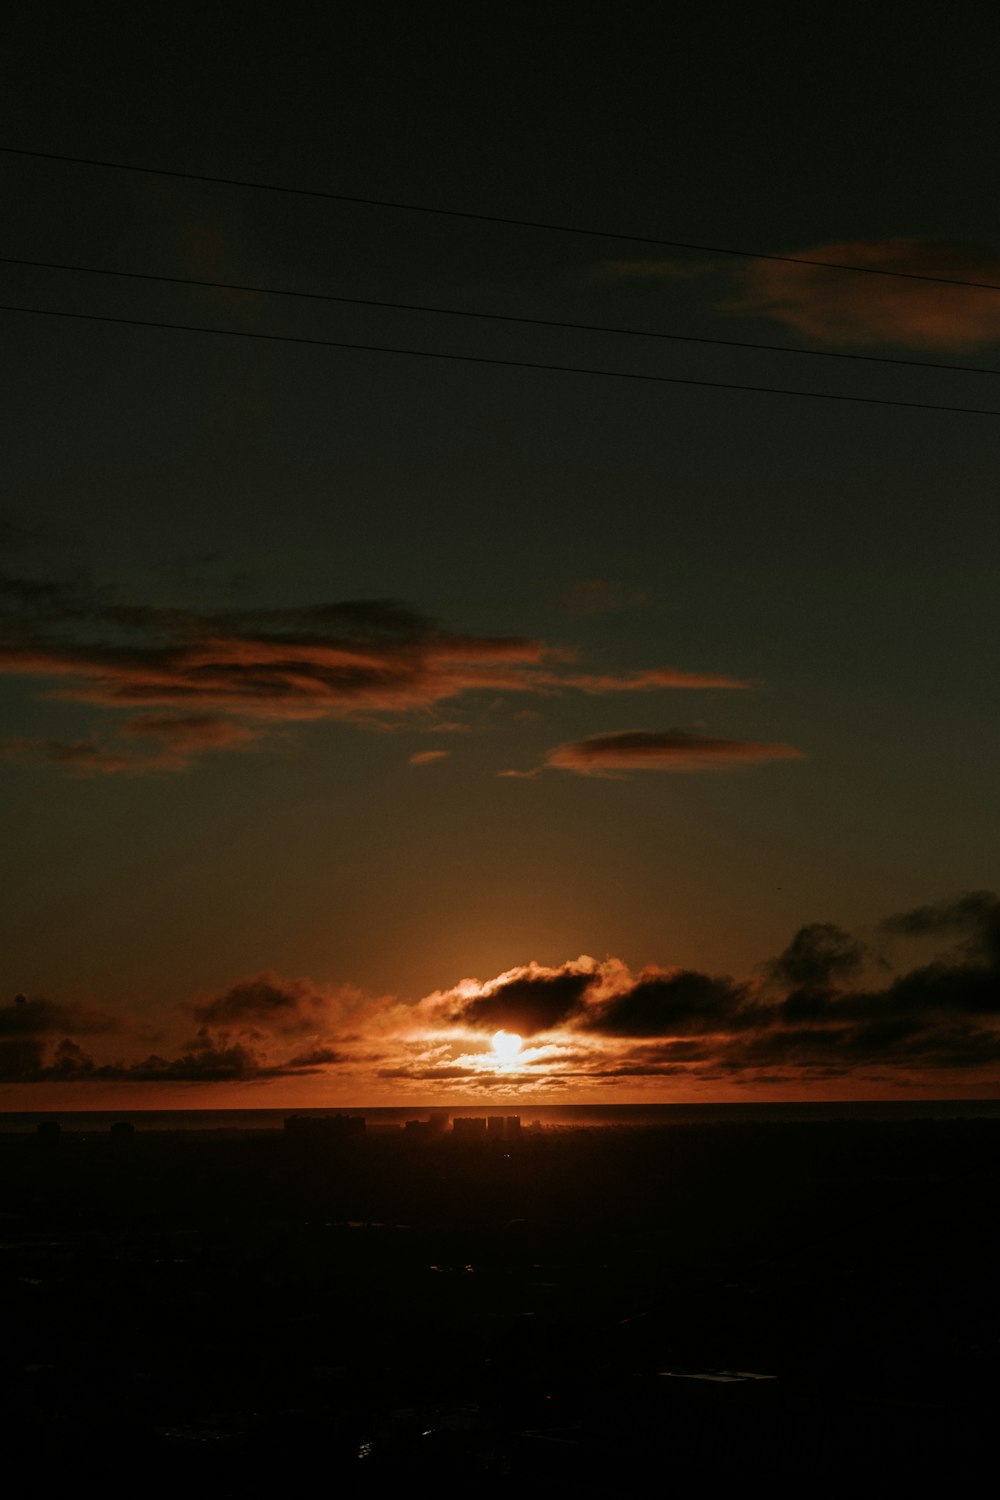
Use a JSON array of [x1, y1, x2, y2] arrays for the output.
[[726, 239, 1000, 353]]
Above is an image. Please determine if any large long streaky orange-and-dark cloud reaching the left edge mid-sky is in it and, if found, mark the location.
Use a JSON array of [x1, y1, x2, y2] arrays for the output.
[[0, 581, 543, 722]]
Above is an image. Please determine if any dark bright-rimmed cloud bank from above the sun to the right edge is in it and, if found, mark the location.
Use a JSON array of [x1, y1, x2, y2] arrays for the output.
[[406, 893, 1000, 1085]]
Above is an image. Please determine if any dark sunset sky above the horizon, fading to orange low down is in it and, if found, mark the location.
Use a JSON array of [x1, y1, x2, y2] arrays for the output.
[[0, 3, 1000, 1109]]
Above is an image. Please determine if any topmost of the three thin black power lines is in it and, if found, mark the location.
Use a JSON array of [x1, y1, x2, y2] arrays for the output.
[[7, 146, 1000, 291]]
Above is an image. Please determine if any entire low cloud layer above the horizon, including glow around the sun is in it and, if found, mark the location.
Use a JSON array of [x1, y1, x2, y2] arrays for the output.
[[9, 891, 1000, 1101]]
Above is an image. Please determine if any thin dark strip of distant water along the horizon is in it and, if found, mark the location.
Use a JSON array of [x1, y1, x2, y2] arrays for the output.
[[0, 1100, 1000, 1134]]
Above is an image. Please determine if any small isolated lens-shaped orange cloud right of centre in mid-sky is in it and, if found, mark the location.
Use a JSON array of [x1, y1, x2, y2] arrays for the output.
[[544, 729, 802, 776]]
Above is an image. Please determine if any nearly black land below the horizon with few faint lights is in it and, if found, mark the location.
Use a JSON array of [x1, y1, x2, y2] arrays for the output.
[[0, 1121, 1000, 1500]]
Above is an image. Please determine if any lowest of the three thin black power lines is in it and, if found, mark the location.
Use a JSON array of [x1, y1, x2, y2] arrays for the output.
[[0, 303, 1000, 417]]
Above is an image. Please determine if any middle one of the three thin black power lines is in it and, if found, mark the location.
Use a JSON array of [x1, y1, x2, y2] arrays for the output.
[[0, 255, 1000, 375]]
